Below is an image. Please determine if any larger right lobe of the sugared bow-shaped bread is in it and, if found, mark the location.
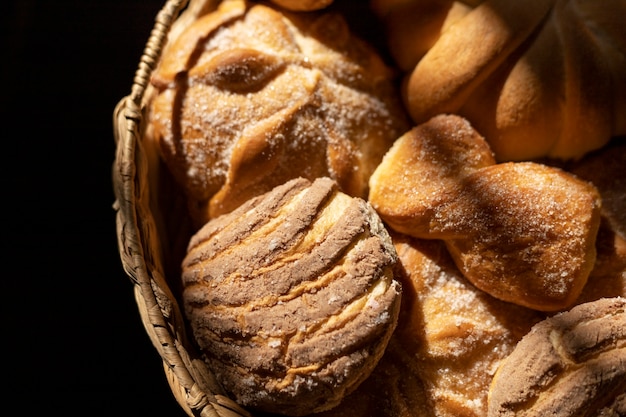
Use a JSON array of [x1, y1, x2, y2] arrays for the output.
[[446, 162, 600, 311]]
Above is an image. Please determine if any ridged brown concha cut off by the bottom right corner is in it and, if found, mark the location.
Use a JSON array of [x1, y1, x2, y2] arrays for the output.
[[488, 298, 626, 417]]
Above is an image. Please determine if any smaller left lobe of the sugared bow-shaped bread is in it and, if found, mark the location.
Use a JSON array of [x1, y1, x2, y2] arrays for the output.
[[369, 116, 495, 238]]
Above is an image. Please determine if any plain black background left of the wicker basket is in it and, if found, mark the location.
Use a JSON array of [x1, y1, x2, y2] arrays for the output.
[[0, 0, 185, 416]]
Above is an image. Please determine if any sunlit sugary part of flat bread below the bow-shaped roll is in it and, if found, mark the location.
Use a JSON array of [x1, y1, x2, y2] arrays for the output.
[[393, 234, 542, 417]]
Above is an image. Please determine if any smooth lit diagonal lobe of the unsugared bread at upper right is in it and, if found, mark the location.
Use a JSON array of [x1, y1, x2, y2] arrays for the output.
[[406, 0, 550, 123]]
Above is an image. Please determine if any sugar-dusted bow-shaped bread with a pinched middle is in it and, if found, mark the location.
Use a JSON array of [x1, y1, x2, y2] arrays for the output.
[[369, 115, 601, 311]]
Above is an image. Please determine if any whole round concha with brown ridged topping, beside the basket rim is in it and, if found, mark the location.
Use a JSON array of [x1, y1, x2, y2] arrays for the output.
[[182, 178, 401, 416]]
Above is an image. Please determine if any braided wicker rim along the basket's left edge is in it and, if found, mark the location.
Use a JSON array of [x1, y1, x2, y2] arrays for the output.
[[113, 0, 250, 417]]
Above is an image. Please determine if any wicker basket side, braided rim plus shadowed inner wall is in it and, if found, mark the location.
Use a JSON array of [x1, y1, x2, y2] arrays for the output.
[[113, 0, 250, 417]]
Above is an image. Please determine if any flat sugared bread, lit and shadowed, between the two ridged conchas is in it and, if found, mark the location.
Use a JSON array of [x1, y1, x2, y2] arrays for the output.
[[314, 234, 543, 417]]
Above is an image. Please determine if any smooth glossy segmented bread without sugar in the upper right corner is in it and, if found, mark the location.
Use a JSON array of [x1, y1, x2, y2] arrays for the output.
[[380, 0, 626, 162]]
